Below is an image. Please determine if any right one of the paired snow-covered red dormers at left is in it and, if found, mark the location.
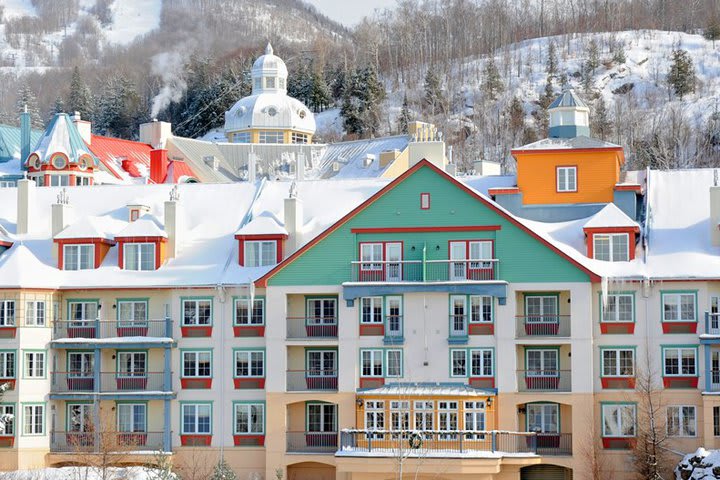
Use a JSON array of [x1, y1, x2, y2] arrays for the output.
[[115, 215, 168, 271]]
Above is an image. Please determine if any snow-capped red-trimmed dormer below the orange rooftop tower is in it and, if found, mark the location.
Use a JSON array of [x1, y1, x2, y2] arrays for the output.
[[583, 203, 640, 262]]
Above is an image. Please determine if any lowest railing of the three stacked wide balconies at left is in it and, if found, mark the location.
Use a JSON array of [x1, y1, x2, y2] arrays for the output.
[[50, 432, 163, 453]]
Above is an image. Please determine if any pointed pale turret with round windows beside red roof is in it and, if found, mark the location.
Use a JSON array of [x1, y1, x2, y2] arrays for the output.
[[27, 113, 99, 187]]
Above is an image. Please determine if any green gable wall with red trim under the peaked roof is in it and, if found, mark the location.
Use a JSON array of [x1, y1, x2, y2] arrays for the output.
[[259, 161, 596, 286]]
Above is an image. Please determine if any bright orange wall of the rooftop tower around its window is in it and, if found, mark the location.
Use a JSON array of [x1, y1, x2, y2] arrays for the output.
[[513, 149, 624, 205]]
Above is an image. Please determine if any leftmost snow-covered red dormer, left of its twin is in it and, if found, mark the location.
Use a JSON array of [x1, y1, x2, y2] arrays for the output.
[[53, 217, 115, 270]]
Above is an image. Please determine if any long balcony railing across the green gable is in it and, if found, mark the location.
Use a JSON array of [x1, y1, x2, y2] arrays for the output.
[[351, 258, 499, 282]]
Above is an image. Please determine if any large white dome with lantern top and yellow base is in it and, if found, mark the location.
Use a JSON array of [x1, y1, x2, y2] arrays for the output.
[[225, 43, 315, 143]]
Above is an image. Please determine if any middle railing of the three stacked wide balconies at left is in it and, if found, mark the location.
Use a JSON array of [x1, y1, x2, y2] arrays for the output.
[[51, 372, 166, 393]]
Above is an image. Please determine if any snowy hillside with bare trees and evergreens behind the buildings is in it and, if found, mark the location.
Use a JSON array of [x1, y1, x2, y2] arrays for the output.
[[0, 0, 720, 171]]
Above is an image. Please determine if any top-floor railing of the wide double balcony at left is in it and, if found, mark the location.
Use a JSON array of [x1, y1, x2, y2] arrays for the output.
[[53, 319, 172, 340]]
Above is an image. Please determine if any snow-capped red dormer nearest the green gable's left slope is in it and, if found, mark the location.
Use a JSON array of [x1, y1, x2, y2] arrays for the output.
[[235, 217, 288, 267]]
